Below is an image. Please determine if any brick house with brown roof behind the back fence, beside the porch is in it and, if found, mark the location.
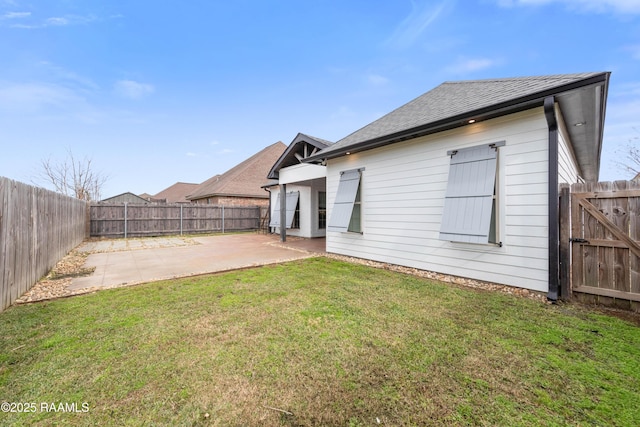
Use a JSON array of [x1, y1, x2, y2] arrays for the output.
[[186, 141, 287, 207]]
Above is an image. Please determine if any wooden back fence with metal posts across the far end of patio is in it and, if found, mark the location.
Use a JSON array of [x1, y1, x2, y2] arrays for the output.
[[90, 203, 260, 238]]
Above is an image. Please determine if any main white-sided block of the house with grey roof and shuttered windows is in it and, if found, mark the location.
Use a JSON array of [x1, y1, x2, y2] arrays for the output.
[[270, 72, 610, 300]]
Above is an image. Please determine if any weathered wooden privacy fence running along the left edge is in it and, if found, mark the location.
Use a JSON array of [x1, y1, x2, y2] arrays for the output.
[[0, 177, 87, 311]]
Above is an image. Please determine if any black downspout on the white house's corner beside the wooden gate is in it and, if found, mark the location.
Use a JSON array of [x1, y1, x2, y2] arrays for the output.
[[544, 96, 560, 302]]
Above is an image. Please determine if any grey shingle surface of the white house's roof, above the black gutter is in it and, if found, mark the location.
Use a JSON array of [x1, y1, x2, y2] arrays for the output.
[[311, 73, 608, 160]]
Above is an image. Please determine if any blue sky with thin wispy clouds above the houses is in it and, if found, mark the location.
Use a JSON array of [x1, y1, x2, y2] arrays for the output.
[[0, 0, 640, 197]]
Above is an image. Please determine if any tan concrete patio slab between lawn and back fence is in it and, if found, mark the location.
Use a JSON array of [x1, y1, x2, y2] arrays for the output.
[[68, 234, 324, 290]]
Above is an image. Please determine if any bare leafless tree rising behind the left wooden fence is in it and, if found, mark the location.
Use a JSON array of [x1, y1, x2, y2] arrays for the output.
[[38, 149, 108, 201]]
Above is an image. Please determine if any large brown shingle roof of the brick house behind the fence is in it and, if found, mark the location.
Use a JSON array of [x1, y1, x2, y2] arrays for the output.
[[187, 141, 287, 200]]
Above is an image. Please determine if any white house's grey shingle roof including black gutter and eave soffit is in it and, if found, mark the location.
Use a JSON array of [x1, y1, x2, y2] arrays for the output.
[[307, 72, 610, 181]]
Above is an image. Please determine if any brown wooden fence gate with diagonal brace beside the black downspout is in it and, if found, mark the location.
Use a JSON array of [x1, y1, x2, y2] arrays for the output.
[[569, 181, 640, 310]]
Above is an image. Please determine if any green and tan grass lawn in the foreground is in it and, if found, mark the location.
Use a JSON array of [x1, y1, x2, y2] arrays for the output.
[[0, 258, 640, 426]]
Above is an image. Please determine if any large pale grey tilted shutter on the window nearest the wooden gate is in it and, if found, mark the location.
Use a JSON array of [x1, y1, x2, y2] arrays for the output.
[[440, 144, 502, 243]]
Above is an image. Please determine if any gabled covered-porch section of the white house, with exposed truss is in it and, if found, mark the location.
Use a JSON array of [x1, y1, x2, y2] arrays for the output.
[[265, 133, 332, 237]]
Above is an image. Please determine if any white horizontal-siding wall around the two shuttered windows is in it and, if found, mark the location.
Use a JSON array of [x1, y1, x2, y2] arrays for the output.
[[327, 108, 548, 291]]
